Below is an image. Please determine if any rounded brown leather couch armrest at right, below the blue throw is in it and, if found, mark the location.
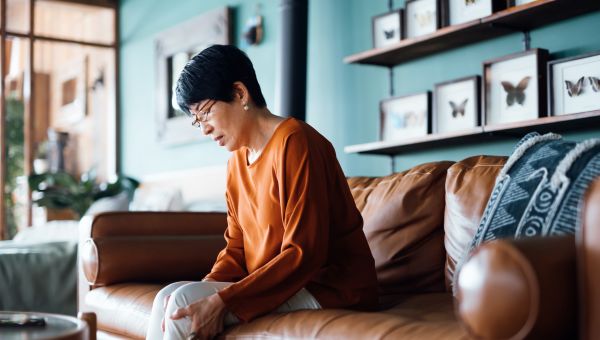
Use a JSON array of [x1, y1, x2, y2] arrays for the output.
[[456, 236, 577, 339]]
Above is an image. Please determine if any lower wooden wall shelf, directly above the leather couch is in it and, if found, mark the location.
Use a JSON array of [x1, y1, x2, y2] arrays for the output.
[[344, 110, 600, 156]]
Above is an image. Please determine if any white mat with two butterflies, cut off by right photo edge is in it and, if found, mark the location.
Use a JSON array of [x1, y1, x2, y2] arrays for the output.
[[552, 55, 600, 116]]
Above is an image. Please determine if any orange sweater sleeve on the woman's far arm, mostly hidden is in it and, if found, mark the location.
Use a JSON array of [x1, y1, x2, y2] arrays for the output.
[[205, 191, 248, 282]]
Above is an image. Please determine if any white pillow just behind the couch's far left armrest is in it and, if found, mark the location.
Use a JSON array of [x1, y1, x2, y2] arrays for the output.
[[129, 187, 184, 211]]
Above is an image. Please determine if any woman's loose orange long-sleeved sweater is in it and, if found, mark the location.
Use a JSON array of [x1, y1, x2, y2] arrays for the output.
[[207, 118, 377, 321]]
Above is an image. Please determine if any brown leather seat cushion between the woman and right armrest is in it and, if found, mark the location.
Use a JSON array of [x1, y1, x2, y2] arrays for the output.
[[221, 293, 468, 340]]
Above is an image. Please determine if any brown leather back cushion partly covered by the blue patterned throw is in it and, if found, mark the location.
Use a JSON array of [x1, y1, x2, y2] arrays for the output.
[[444, 156, 507, 289]]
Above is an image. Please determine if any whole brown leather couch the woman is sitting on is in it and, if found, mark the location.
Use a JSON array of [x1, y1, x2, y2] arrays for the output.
[[79, 156, 600, 340]]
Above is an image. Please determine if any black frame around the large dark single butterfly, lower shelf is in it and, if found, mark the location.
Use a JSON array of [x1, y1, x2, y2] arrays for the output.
[[481, 48, 548, 125]]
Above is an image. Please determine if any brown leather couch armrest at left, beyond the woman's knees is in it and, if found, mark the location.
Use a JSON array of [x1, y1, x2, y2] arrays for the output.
[[79, 212, 227, 287]]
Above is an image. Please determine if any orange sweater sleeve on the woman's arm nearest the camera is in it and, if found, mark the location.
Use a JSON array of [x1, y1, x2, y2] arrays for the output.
[[219, 133, 329, 321]]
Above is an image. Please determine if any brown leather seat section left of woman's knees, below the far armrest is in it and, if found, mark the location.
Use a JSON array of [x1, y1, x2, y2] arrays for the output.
[[85, 283, 166, 339]]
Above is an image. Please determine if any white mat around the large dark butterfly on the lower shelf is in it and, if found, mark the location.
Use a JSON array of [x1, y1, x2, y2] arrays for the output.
[[485, 54, 539, 124]]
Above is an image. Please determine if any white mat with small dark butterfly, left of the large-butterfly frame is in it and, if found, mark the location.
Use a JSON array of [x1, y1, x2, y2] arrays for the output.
[[434, 79, 477, 133]]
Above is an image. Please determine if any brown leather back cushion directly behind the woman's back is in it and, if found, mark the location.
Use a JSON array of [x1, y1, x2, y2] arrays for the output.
[[348, 162, 452, 305]]
